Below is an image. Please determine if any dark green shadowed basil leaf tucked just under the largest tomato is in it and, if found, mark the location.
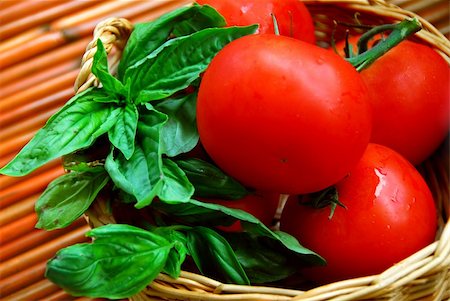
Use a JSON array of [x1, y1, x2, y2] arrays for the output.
[[175, 158, 248, 200]]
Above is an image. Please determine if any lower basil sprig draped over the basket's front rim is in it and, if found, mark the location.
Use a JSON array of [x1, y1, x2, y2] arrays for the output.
[[46, 211, 323, 299]]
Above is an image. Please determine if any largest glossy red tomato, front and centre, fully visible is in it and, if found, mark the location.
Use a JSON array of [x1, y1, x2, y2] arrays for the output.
[[197, 34, 372, 194]]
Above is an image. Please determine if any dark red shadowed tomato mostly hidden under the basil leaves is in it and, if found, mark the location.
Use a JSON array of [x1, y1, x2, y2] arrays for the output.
[[202, 193, 280, 232]]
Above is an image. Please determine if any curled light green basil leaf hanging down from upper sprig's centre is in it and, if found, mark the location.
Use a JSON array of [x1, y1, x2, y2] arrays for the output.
[[105, 111, 167, 208]]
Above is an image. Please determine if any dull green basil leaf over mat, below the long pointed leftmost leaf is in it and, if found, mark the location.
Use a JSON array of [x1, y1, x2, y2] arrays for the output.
[[35, 167, 109, 230]]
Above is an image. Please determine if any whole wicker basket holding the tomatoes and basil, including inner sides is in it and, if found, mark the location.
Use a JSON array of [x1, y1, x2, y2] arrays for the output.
[[75, 0, 450, 301]]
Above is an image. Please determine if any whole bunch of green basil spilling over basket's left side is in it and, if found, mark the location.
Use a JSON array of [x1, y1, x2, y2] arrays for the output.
[[0, 5, 323, 298]]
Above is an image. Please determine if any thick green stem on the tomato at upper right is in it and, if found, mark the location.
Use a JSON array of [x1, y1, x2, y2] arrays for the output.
[[346, 18, 422, 72]]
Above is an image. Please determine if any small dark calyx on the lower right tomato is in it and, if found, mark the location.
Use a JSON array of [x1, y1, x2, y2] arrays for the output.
[[299, 186, 347, 219]]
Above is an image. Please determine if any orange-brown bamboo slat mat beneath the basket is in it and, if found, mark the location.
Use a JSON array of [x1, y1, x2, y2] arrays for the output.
[[0, 0, 450, 301]]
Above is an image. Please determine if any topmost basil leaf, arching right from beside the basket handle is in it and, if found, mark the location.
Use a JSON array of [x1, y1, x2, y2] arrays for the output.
[[118, 5, 226, 78]]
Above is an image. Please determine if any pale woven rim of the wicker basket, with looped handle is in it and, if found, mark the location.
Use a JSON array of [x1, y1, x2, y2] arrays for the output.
[[75, 0, 450, 300]]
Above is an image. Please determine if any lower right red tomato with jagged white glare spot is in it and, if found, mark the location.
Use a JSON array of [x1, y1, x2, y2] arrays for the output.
[[280, 144, 437, 282]]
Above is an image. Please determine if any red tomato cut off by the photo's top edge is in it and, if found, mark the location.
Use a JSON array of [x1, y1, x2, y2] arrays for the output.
[[197, 0, 316, 44]]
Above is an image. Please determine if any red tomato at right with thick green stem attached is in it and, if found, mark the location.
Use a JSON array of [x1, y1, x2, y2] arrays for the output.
[[338, 37, 450, 164]]
